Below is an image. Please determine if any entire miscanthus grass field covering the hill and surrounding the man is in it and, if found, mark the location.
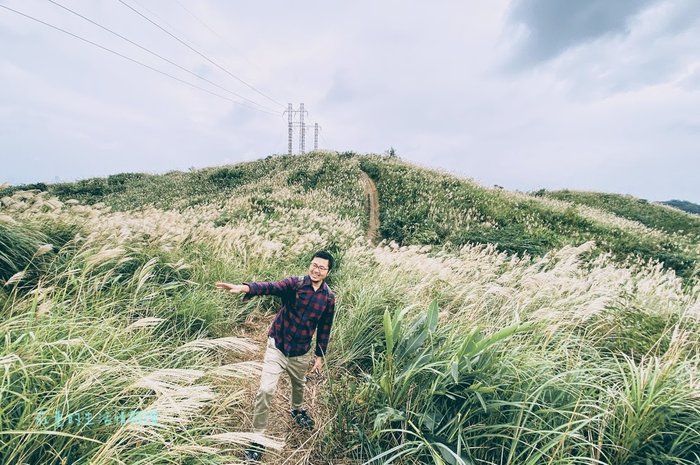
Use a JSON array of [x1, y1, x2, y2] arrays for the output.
[[0, 153, 700, 465]]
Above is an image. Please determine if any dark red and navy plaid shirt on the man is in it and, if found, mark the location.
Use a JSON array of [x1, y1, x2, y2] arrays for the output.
[[243, 275, 335, 357]]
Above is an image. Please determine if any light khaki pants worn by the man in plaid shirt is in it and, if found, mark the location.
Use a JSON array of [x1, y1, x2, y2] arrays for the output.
[[253, 337, 312, 433]]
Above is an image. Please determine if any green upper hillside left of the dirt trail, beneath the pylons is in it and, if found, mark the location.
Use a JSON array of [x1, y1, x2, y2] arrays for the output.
[[0, 154, 364, 219]]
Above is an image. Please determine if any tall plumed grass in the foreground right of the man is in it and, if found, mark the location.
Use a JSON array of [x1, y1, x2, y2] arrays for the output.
[[325, 237, 700, 464]]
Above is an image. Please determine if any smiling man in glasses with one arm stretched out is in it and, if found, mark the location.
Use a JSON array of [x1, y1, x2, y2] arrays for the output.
[[216, 250, 335, 461]]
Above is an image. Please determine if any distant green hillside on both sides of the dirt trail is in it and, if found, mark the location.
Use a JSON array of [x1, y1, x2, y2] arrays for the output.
[[5, 154, 700, 280]]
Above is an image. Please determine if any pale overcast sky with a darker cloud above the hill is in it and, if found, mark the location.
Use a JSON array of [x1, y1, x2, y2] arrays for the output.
[[0, 0, 700, 203]]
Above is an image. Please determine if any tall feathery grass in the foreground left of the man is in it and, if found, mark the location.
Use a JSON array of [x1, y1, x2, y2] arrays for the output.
[[0, 195, 292, 464]]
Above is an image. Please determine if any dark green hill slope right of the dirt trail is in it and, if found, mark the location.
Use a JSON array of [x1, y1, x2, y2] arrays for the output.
[[360, 157, 700, 280]]
